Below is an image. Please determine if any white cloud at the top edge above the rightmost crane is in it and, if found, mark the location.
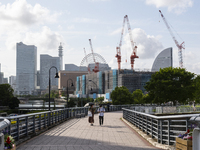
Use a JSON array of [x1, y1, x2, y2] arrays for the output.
[[146, 0, 193, 14]]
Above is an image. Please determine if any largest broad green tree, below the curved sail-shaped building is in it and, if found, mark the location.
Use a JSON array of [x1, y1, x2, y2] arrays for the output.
[[144, 67, 195, 104]]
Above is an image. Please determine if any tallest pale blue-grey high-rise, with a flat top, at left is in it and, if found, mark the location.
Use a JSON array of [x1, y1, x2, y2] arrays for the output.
[[16, 42, 37, 95]]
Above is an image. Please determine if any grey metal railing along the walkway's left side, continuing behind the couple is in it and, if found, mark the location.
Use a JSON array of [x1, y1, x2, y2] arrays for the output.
[[1, 105, 130, 141]]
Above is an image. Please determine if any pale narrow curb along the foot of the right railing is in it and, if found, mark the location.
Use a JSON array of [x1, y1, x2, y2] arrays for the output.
[[122, 118, 174, 150]]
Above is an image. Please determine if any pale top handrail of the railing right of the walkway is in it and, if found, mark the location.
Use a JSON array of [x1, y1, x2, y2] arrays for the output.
[[122, 108, 200, 119]]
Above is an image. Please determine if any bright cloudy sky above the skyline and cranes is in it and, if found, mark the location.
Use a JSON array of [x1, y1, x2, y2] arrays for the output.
[[0, 0, 200, 77]]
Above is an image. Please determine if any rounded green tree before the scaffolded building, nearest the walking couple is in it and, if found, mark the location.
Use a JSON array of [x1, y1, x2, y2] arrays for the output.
[[111, 86, 133, 105]]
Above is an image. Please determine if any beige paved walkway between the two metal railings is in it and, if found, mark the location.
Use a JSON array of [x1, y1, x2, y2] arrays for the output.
[[17, 111, 161, 150]]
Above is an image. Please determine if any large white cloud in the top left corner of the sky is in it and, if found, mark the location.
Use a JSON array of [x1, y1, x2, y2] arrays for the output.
[[0, 0, 59, 33]]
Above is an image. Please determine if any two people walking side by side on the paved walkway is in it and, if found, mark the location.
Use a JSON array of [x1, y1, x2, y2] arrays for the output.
[[88, 105, 105, 126]]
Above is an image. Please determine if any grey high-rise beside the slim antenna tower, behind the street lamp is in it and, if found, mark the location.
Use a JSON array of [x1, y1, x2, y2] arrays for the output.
[[40, 54, 60, 90]]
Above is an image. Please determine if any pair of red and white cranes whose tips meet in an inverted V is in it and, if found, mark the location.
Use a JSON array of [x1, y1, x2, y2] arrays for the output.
[[115, 15, 139, 70]]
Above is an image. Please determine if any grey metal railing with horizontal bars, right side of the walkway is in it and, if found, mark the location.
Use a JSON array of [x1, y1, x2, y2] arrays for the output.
[[123, 108, 199, 145]]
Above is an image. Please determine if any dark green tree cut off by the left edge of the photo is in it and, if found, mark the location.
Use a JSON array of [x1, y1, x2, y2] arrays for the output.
[[0, 84, 14, 106]]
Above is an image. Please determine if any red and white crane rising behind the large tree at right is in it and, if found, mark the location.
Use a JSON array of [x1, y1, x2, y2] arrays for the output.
[[159, 10, 185, 68]]
